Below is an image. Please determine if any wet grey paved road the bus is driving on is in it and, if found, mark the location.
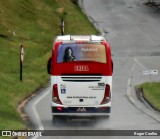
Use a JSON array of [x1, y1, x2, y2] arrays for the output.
[[25, 0, 160, 139]]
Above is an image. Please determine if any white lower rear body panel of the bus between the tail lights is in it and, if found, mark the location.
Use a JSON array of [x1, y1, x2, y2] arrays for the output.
[[51, 76, 112, 108]]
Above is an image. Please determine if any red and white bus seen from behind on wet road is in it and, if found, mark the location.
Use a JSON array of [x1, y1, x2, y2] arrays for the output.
[[48, 35, 113, 116]]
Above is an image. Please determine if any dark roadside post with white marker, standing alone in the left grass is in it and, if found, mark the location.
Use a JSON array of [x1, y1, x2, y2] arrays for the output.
[[20, 45, 24, 81]]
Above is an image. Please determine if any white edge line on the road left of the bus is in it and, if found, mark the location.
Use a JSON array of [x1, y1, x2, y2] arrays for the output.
[[32, 90, 50, 139]]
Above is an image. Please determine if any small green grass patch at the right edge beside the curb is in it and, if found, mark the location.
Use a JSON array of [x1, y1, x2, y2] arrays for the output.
[[141, 82, 160, 110]]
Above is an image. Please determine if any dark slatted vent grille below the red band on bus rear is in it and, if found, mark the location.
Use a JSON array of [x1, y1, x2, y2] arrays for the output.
[[61, 75, 102, 82]]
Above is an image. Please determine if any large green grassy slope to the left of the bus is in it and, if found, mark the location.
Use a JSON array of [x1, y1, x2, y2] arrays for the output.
[[0, 0, 98, 136]]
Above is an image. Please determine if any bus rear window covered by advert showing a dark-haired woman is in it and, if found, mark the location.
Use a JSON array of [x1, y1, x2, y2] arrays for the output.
[[57, 43, 107, 63]]
